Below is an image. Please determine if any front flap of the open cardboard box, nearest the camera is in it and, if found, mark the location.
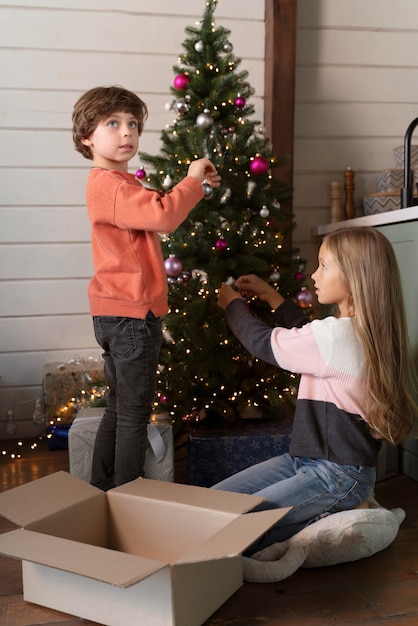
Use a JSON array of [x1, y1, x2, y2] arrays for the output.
[[0, 529, 168, 587]]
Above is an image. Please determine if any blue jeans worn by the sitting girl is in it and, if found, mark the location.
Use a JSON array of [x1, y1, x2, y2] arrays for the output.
[[212, 454, 376, 554]]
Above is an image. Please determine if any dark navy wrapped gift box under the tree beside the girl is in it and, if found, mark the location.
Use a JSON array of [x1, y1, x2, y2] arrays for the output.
[[188, 418, 292, 487]]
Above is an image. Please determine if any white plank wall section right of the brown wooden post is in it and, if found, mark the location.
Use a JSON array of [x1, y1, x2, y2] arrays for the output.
[[294, 0, 418, 272]]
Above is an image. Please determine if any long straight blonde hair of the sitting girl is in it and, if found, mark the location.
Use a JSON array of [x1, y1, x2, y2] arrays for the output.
[[324, 227, 418, 444]]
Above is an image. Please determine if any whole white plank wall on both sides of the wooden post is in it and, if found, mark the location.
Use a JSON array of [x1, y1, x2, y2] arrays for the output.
[[0, 0, 418, 438]]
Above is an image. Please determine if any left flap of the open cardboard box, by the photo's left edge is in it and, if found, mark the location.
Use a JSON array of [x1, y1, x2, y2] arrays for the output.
[[0, 471, 101, 528]]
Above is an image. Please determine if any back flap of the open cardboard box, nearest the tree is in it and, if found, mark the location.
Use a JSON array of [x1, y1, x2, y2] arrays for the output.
[[107, 478, 264, 516]]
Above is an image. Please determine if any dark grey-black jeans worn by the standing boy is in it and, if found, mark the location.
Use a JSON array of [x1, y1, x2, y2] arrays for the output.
[[91, 311, 162, 491]]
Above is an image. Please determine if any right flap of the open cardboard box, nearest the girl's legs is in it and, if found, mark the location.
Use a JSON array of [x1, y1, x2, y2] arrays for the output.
[[178, 507, 292, 563]]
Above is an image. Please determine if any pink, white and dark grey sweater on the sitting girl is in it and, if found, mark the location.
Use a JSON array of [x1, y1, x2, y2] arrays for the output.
[[226, 300, 381, 466]]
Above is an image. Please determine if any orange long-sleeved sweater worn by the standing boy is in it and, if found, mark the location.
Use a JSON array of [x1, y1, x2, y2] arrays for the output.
[[86, 168, 203, 319]]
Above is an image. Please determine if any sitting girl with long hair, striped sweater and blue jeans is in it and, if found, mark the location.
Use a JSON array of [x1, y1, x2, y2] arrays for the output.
[[213, 228, 418, 554]]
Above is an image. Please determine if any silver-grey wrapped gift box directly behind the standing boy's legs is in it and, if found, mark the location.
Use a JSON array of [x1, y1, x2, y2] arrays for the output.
[[68, 410, 174, 482]]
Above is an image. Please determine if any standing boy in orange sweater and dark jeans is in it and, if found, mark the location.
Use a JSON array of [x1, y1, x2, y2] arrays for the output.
[[73, 86, 220, 490]]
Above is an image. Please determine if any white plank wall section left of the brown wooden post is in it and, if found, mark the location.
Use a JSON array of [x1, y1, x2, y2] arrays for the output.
[[0, 0, 264, 439]]
